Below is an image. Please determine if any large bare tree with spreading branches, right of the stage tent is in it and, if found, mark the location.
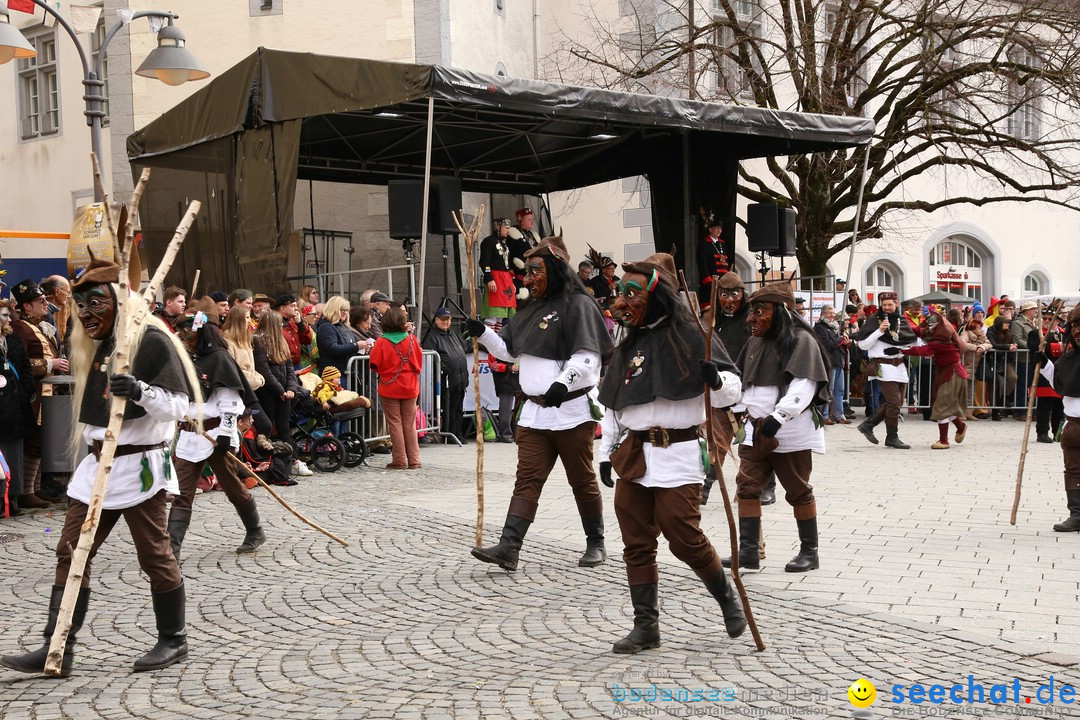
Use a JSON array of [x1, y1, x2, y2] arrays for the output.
[[552, 0, 1080, 275]]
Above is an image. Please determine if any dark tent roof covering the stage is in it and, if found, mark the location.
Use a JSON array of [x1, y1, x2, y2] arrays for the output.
[[127, 49, 874, 193]]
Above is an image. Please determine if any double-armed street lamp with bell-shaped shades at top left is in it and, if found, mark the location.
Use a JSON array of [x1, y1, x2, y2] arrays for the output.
[[0, 0, 210, 202]]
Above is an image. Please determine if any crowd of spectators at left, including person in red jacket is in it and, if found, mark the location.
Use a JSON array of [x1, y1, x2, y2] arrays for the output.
[[0, 275, 423, 517]]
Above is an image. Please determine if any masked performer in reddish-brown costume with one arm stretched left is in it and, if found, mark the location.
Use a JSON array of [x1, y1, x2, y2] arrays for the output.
[[885, 311, 969, 450]]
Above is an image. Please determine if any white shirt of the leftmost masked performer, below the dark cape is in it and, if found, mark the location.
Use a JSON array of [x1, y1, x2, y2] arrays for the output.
[[68, 386, 188, 510]]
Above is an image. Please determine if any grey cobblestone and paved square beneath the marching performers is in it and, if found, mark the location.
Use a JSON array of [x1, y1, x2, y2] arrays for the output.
[[0, 420, 1080, 720]]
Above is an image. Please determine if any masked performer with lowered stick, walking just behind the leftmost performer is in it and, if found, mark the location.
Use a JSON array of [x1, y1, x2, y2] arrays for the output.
[[168, 298, 266, 558]]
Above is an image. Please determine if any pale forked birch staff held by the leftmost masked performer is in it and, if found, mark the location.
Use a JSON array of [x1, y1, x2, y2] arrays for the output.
[[45, 162, 202, 677]]
